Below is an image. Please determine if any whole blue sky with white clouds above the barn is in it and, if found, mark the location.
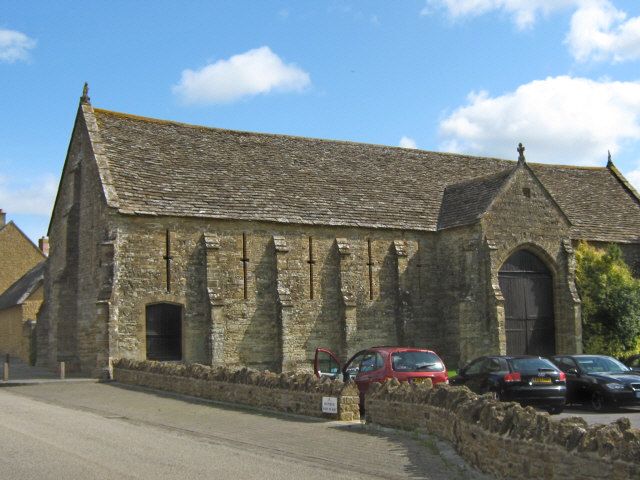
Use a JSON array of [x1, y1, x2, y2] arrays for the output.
[[0, 0, 640, 240]]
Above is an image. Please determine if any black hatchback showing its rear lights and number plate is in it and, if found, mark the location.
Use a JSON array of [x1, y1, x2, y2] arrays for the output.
[[451, 355, 567, 414]]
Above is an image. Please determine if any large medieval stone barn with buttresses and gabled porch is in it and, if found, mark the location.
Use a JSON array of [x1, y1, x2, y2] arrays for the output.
[[38, 89, 640, 374]]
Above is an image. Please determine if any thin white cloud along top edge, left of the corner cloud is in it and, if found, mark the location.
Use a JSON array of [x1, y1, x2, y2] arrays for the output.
[[421, 0, 583, 29]]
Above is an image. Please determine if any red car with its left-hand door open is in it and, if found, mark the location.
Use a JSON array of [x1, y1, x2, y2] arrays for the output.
[[313, 347, 449, 404]]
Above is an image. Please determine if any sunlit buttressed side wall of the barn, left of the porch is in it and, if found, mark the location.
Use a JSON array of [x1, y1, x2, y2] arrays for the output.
[[113, 216, 422, 371]]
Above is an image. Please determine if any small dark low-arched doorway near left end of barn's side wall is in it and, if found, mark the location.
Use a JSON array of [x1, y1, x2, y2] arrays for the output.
[[146, 303, 182, 361]]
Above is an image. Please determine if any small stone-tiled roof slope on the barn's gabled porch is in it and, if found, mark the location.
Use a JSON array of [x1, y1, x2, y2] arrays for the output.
[[438, 168, 514, 229]]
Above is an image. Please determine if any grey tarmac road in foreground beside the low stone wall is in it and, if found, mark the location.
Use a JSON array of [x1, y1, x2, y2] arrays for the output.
[[0, 382, 490, 480]]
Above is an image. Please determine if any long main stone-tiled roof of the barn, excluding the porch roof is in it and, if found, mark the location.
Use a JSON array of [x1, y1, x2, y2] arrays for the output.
[[82, 109, 640, 242]]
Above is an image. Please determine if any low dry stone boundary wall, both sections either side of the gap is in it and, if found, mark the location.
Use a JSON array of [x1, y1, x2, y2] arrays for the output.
[[113, 359, 640, 480]]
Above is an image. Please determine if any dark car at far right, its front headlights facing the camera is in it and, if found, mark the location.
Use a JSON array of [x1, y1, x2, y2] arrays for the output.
[[552, 355, 640, 411]]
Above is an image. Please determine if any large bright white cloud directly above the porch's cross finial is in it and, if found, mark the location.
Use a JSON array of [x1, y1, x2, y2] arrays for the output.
[[440, 76, 640, 165]]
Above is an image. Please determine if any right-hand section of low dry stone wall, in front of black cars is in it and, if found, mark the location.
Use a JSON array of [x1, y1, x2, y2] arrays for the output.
[[366, 380, 640, 480]]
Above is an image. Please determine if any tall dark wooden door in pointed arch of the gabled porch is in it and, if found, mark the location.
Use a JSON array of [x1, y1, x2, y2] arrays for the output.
[[498, 250, 556, 356]]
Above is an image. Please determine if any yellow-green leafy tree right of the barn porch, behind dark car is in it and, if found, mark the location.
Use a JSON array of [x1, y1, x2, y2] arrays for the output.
[[576, 242, 640, 356]]
